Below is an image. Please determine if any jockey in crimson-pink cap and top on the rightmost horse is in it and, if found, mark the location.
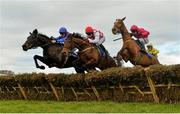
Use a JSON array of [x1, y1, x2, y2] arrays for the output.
[[130, 25, 150, 50]]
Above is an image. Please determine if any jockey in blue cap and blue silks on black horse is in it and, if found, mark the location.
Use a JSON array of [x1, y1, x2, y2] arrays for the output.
[[52, 27, 78, 57]]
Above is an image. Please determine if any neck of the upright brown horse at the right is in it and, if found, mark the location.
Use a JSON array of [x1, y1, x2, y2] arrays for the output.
[[120, 23, 131, 42]]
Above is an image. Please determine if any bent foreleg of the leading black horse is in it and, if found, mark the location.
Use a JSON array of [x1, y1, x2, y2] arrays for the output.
[[34, 55, 48, 70]]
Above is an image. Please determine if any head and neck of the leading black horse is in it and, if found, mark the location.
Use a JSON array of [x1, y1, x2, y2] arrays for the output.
[[22, 29, 50, 51]]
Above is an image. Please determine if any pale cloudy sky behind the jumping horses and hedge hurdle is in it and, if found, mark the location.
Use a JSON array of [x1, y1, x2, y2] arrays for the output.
[[0, 0, 180, 73]]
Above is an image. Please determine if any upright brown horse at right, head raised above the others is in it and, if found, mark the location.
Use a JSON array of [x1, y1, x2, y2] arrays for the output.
[[112, 17, 159, 67]]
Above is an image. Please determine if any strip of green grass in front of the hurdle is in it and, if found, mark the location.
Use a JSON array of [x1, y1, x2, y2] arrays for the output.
[[0, 100, 180, 113]]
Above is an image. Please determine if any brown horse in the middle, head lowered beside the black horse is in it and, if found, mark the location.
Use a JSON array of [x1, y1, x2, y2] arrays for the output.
[[62, 35, 117, 70]]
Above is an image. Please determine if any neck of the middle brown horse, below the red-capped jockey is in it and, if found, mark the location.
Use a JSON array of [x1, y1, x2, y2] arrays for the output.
[[73, 38, 91, 50]]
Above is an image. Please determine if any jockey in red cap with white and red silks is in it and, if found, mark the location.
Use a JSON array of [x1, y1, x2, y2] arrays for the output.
[[85, 26, 109, 55]]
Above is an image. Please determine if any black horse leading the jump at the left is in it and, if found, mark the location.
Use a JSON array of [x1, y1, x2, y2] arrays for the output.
[[22, 29, 84, 73]]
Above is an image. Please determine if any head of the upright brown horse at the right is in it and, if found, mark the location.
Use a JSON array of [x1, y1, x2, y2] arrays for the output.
[[112, 17, 126, 35]]
